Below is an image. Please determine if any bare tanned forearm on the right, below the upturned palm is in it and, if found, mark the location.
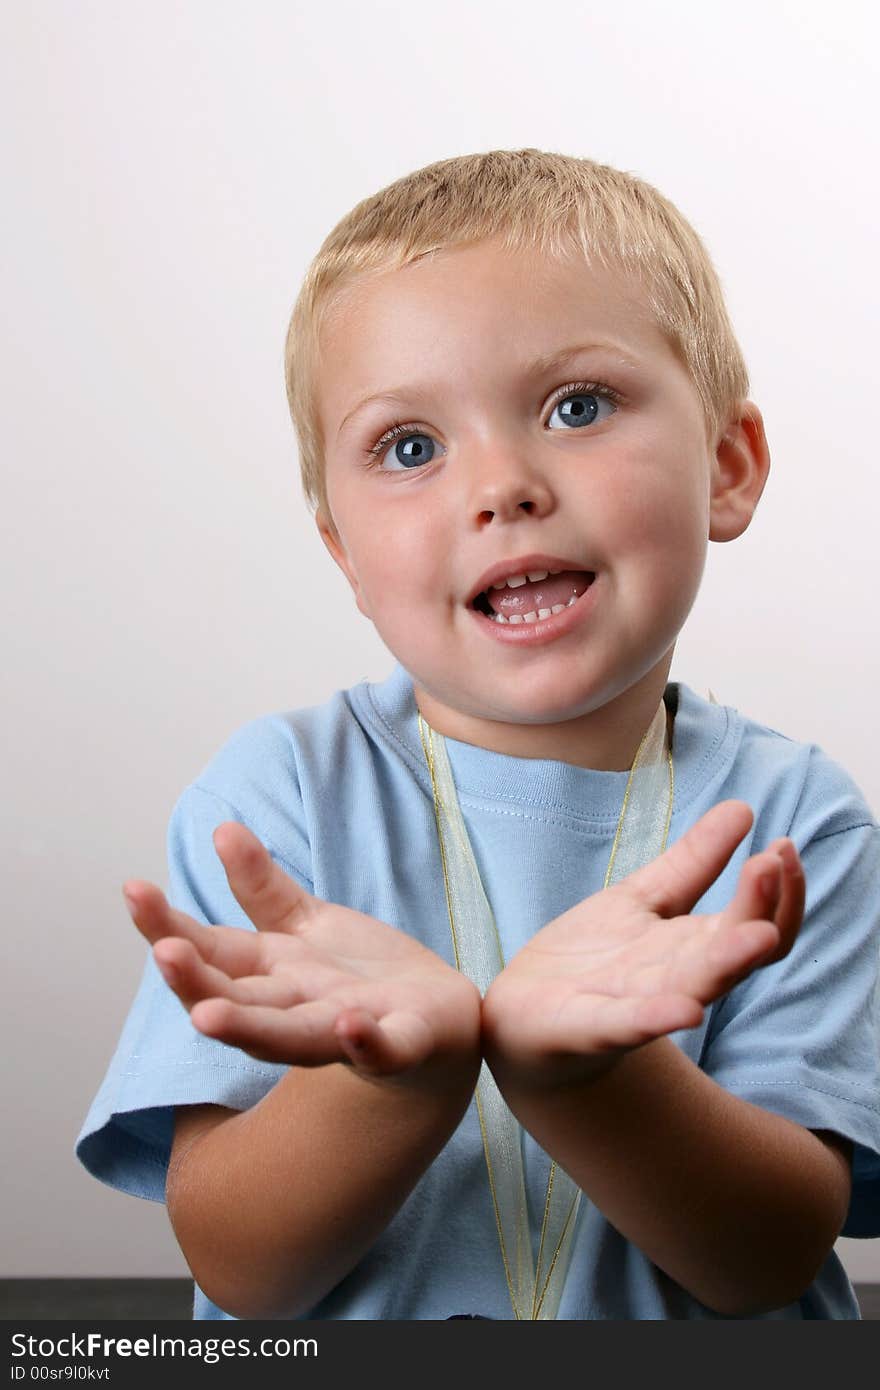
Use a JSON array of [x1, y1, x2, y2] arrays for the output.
[[486, 1037, 845, 1316]]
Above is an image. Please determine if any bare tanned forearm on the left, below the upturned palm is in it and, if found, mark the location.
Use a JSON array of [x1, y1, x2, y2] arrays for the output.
[[168, 1055, 480, 1318]]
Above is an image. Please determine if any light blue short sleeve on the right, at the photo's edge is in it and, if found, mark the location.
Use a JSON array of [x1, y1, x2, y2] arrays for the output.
[[701, 755, 880, 1237]]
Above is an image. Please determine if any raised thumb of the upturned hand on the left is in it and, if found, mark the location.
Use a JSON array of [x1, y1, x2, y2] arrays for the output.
[[213, 820, 320, 933]]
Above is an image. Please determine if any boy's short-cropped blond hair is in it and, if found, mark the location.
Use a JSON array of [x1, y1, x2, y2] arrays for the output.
[[284, 149, 749, 520]]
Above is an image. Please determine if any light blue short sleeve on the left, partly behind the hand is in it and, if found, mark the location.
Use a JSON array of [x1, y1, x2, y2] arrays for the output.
[[75, 756, 313, 1201]]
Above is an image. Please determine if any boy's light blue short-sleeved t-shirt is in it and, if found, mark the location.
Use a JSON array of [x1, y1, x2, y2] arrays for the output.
[[76, 664, 880, 1319]]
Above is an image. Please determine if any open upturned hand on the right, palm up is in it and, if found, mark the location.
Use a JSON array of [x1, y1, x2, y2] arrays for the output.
[[482, 801, 806, 1086]]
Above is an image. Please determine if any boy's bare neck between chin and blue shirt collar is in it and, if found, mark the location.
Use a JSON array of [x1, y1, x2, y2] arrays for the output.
[[413, 651, 673, 771]]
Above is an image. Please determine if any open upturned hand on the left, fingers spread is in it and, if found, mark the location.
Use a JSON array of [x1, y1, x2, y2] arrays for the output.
[[124, 821, 480, 1084]]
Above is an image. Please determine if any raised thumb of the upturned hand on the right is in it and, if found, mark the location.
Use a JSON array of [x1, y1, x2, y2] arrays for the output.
[[619, 801, 755, 917]]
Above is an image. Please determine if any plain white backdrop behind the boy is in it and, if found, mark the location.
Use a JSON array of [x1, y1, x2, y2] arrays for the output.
[[0, 0, 880, 1280]]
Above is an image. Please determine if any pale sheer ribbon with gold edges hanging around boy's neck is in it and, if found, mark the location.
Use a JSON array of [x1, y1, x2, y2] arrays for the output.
[[418, 701, 674, 1321]]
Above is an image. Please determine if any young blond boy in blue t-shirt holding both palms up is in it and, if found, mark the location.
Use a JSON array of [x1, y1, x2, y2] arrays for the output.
[[76, 149, 880, 1319]]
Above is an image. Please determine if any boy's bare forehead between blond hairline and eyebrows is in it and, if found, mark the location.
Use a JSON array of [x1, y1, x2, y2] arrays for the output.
[[318, 242, 673, 441]]
